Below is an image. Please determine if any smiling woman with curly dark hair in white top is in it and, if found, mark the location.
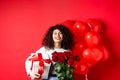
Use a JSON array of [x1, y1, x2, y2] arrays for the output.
[[25, 24, 73, 80]]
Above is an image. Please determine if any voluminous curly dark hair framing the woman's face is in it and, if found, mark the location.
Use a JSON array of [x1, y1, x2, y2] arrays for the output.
[[42, 24, 73, 50]]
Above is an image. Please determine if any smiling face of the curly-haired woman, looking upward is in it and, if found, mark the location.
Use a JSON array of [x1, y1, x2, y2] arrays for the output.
[[52, 29, 63, 43]]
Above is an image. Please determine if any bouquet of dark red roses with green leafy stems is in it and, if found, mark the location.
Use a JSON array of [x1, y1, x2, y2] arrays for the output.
[[52, 52, 74, 80]]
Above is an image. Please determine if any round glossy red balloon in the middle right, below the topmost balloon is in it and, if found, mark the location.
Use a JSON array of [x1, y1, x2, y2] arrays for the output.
[[84, 32, 100, 48]]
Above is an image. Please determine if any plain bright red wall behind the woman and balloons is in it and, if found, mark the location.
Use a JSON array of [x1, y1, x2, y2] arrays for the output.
[[0, 0, 120, 80]]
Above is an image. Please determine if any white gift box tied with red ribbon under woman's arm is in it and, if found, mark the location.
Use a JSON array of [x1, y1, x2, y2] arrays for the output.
[[28, 53, 50, 79]]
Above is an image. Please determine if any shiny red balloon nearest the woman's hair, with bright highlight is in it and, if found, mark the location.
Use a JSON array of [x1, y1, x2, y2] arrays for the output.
[[73, 21, 89, 36]]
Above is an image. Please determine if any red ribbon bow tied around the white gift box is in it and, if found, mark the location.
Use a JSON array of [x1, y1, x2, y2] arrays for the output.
[[28, 53, 50, 75]]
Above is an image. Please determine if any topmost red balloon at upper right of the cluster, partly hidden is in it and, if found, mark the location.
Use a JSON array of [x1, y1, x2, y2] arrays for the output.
[[86, 19, 102, 32]]
